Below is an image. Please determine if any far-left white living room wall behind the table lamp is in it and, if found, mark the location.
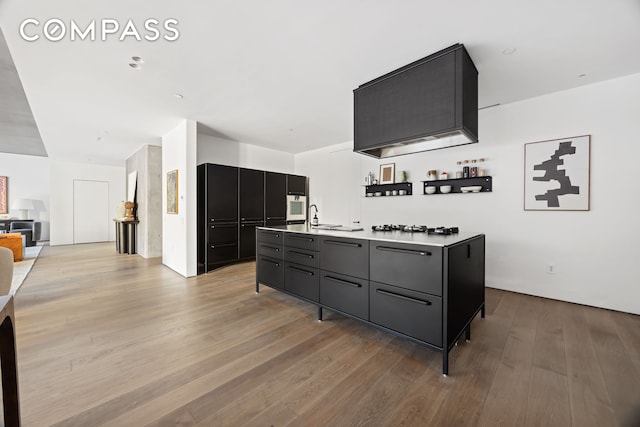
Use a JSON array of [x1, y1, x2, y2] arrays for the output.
[[0, 153, 50, 240]]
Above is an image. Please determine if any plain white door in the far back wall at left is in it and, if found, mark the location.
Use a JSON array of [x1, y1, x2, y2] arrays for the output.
[[73, 179, 110, 243]]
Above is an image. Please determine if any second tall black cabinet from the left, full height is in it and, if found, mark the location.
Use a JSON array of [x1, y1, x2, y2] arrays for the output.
[[239, 169, 265, 259]]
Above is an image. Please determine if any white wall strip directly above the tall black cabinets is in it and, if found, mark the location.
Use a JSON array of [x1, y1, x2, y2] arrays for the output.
[[197, 132, 295, 173]]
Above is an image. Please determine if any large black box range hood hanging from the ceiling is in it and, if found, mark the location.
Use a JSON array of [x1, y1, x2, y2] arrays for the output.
[[353, 44, 478, 158]]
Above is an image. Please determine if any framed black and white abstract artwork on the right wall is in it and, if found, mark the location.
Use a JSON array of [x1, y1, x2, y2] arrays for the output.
[[524, 135, 591, 211]]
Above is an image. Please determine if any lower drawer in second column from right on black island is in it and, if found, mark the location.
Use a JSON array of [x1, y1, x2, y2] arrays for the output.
[[320, 271, 369, 320]]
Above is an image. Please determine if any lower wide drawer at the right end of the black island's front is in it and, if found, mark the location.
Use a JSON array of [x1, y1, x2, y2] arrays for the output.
[[369, 282, 442, 347]]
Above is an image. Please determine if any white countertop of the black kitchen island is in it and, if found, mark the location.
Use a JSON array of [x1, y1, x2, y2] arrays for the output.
[[258, 224, 482, 246]]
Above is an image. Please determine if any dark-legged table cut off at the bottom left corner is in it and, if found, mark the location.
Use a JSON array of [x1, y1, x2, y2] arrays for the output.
[[0, 295, 20, 427]]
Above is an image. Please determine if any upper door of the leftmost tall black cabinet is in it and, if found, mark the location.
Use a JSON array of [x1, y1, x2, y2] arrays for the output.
[[206, 164, 238, 222]]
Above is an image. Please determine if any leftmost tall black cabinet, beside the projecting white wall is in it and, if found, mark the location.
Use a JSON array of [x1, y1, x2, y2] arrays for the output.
[[197, 164, 239, 272]]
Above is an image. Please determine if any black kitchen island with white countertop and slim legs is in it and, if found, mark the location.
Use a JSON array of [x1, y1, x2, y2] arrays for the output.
[[256, 225, 485, 375]]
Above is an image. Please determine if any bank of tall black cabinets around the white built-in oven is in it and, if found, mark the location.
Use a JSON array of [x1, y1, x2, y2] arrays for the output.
[[198, 163, 307, 273]]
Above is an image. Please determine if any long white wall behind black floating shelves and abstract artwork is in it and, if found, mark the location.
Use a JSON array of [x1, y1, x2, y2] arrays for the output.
[[296, 74, 640, 314]]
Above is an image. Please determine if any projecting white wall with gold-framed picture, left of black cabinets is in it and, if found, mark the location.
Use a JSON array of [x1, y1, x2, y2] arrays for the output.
[[162, 120, 197, 277]]
